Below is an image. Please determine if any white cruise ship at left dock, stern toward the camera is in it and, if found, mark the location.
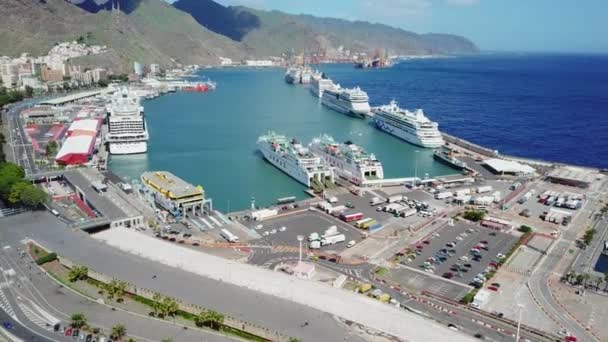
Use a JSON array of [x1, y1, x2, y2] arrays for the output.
[[106, 88, 148, 154]]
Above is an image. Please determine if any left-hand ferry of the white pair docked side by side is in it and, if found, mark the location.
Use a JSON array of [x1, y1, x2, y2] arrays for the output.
[[258, 132, 334, 188]]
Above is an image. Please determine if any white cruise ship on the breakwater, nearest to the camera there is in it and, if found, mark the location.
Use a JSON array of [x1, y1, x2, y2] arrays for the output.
[[372, 100, 443, 148]]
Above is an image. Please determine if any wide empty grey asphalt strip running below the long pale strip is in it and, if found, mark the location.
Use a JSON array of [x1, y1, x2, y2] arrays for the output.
[[0, 212, 363, 341]]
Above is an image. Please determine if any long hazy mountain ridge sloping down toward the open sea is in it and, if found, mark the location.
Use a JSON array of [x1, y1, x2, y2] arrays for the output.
[[173, 0, 478, 56]]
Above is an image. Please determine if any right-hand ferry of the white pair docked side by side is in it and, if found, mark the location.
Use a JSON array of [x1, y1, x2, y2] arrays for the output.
[[310, 135, 384, 185]]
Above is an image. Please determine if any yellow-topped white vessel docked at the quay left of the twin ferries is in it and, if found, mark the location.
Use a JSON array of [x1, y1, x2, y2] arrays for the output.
[[141, 171, 213, 220]]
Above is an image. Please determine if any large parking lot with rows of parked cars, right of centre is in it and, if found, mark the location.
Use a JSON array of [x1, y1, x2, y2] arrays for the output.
[[402, 223, 517, 284]]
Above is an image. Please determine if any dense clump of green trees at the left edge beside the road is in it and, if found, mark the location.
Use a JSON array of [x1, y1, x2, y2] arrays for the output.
[[0, 162, 48, 208]]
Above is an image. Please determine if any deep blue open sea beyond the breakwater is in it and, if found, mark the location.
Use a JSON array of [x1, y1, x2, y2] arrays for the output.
[[323, 54, 608, 168]]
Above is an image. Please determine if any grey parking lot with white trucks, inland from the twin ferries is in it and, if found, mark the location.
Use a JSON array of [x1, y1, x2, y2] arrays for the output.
[[256, 210, 363, 251]]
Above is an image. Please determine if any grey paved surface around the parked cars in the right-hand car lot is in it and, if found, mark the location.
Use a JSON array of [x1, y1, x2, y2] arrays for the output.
[[407, 223, 517, 284]]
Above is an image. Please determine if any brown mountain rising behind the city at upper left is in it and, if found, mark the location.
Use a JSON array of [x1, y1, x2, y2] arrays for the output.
[[0, 0, 245, 70]]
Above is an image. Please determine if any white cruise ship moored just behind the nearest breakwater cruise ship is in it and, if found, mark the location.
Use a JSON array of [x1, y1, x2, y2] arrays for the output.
[[321, 86, 370, 118]]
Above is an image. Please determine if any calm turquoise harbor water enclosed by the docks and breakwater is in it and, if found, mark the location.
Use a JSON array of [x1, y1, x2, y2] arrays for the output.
[[109, 66, 458, 211]]
